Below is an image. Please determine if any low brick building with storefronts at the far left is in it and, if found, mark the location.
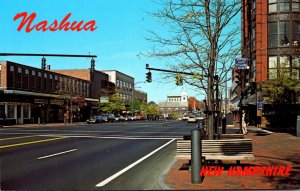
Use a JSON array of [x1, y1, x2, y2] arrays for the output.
[[0, 61, 94, 124]]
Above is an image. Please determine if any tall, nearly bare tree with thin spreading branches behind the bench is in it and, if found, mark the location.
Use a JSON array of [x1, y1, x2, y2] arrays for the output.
[[146, 0, 241, 139]]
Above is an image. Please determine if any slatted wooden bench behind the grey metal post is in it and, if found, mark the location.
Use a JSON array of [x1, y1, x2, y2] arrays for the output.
[[176, 139, 254, 163]]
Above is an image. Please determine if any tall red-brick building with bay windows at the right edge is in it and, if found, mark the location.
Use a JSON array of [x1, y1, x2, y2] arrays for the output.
[[236, 0, 300, 127]]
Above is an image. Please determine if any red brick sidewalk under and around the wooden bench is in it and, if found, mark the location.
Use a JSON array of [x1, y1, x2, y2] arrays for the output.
[[164, 127, 300, 190]]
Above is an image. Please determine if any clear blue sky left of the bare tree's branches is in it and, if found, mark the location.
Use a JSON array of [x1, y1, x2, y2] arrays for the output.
[[0, 0, 207, 102]]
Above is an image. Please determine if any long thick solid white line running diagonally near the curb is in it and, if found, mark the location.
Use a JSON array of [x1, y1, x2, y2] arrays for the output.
[[96, 139, 175, 187]]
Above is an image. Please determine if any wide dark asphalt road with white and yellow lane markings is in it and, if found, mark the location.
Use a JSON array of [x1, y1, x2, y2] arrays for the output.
[[0, 121, 195, 190]]
